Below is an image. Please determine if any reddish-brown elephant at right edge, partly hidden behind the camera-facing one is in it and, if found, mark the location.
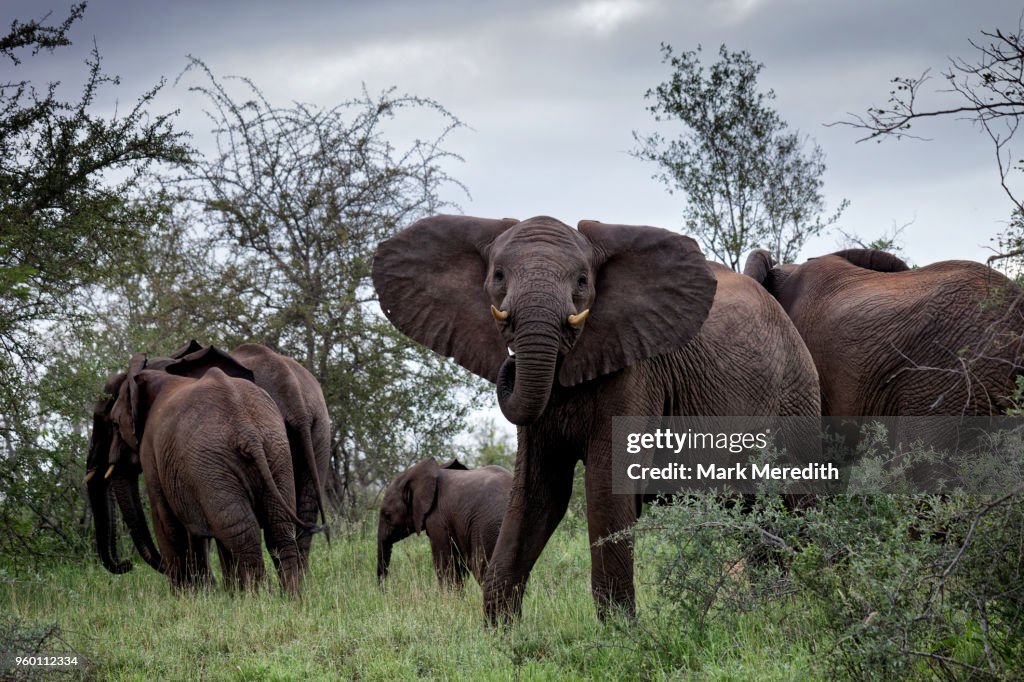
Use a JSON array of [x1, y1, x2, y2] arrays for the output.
[[744, 249, 1024, 417]]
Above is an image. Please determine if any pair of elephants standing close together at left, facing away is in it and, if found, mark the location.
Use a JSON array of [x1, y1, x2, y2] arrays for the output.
[[86, 341, 331, 594]]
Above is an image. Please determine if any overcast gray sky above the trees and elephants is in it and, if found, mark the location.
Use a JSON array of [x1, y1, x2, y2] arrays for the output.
[[8, 0, 1024, 264]]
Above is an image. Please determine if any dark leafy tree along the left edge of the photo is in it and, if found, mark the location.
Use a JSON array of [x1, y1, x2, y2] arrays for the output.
[[0, 3, 188, 556]]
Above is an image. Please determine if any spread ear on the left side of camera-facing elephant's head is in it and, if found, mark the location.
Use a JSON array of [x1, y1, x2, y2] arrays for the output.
[[373, 215, 517, 382]]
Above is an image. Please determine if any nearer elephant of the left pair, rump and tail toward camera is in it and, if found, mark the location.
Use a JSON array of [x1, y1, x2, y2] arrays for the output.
[[111, 353, 315, 595]]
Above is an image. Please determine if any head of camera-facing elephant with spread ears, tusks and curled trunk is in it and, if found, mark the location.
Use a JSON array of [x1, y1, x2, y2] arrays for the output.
[[373, 215, 716, 425]]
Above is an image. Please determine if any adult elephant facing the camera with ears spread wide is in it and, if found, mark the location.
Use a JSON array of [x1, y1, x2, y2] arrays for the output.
[[373, 216, 819, 622]]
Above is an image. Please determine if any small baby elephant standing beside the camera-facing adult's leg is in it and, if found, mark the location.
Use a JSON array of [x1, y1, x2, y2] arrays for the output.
[[377, 458, 512, 589]]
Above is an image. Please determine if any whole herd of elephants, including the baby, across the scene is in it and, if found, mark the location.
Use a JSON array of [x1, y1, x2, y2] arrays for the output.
[[87, 215, 1024, 623]]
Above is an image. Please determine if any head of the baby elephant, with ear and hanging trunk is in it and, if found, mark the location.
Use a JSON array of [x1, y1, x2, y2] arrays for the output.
[[377, 457, 466, 583]]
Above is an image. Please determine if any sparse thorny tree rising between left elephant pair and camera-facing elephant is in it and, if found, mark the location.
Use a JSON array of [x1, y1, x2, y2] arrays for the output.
[[167, 58, 479, 516]]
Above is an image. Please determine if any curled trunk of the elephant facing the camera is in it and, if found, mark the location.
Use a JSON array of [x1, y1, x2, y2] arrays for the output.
[[498, 316, 561, 426]]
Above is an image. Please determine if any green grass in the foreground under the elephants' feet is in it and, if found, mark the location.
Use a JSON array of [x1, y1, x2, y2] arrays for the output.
[[0, 516, 816, 680]]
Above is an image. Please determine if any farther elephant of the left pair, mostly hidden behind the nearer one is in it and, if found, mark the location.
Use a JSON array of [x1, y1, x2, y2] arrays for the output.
[[86, 340, 331, 573]]
